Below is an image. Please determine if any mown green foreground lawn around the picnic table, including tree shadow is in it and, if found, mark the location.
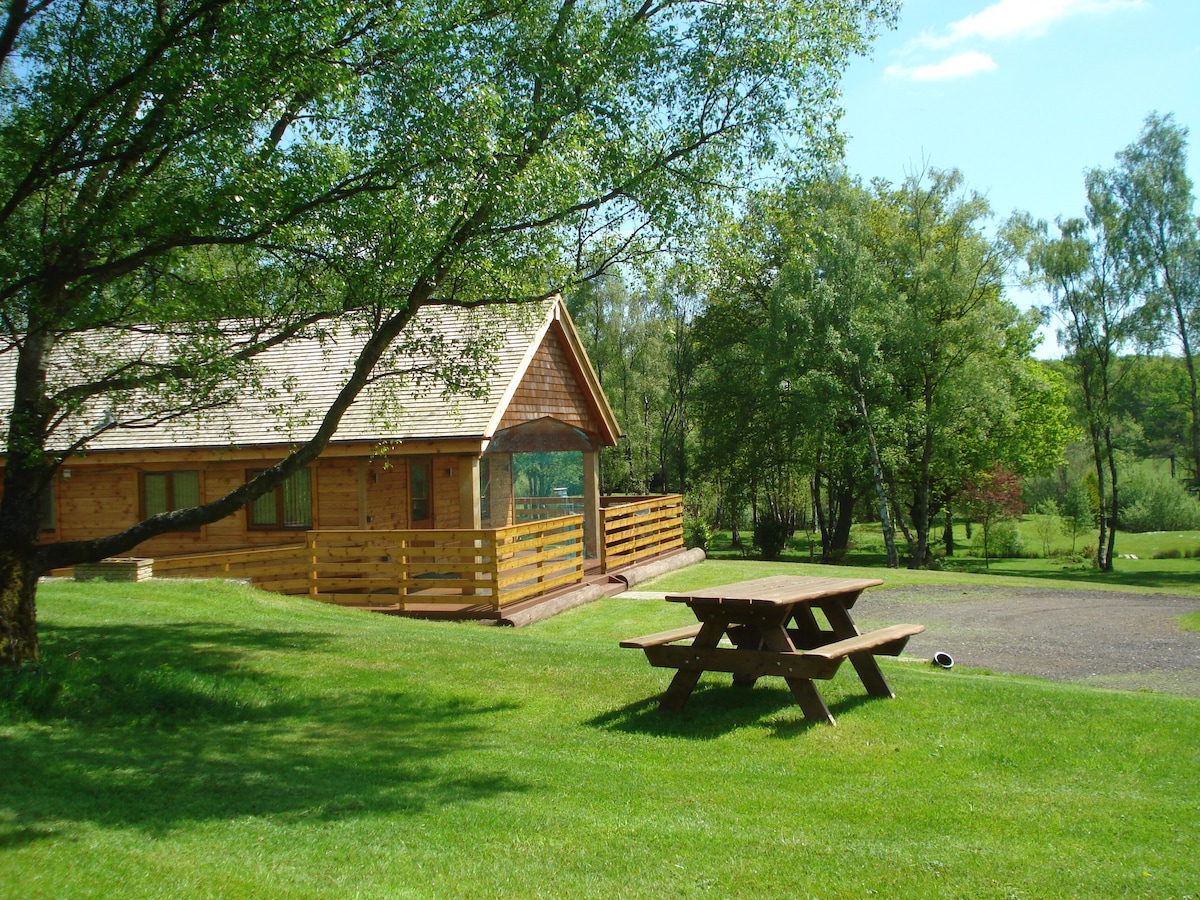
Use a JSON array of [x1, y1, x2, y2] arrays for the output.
[[0, 578, 1200, 900]]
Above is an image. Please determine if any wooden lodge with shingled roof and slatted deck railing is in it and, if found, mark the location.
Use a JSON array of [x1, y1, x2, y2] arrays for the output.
[[0, 299, 683, 619]]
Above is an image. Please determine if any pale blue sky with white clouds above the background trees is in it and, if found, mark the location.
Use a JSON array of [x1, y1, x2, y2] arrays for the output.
[[842, 0, 1200, 355]]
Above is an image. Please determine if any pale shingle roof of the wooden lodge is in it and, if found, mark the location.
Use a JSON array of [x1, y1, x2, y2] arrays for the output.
[[0, 299, 617, 451]]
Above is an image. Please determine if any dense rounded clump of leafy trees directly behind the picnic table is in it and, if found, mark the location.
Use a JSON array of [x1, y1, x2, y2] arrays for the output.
[[695, 172, 1069, 559]]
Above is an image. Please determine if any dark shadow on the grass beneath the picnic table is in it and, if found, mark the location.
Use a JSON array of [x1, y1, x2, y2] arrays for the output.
[[587, 683, 872, 740]]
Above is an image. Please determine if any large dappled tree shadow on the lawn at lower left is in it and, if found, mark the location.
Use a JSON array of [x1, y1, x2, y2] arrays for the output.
[[0, 623, 527, 846]]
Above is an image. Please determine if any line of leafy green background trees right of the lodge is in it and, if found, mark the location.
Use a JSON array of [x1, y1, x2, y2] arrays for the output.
[[569, 116, 1200, 568]]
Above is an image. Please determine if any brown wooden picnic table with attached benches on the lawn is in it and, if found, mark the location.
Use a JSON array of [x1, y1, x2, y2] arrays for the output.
[[620, 575, 925, 725]]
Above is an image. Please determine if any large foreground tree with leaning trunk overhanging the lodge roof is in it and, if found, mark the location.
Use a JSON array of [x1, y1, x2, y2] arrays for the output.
[[0, 0, 898, 660]]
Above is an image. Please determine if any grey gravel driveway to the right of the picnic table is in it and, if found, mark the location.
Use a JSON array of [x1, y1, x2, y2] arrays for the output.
[[854, 587, 1200, 697]]
